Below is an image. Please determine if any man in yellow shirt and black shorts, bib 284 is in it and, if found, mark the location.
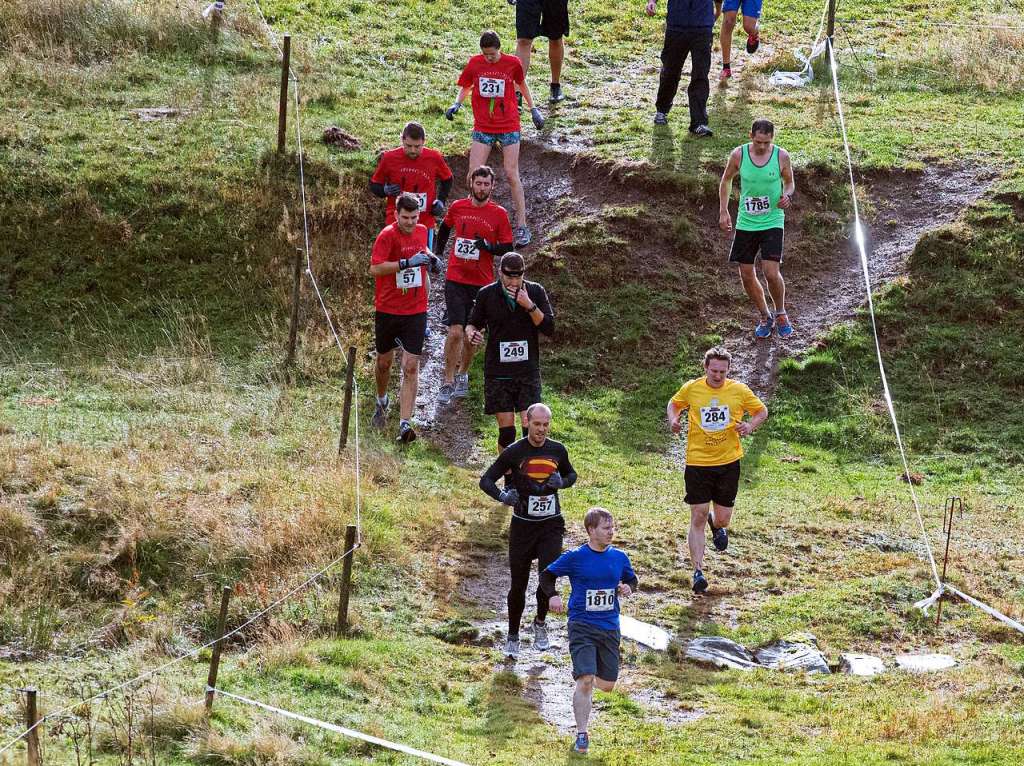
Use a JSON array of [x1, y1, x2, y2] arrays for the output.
[[668, 346, 768, 593]]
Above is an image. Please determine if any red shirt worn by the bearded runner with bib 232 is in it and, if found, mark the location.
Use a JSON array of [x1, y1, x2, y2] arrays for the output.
[[444, 197, 512, 287]]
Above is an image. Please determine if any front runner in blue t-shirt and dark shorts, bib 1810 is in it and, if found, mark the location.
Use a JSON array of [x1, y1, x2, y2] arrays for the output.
[[540, 508, 638, 753]]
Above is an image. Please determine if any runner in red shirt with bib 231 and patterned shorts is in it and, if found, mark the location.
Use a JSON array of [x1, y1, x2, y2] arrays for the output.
[[444, 31, 544, 245]]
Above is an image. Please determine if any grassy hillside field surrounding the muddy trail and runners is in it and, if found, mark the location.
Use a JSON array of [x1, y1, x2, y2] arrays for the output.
[[0, 0, 1024, 766]]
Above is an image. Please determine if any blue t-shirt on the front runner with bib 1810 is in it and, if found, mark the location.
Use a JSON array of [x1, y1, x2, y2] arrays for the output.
[[547, 543, 637, 631]]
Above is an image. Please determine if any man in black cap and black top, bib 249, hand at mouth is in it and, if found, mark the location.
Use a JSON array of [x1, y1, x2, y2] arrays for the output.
[[466, 253, 555, 452]]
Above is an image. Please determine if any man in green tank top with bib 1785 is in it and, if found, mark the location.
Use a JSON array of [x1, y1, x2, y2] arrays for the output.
[[718, 120, 796, 338]]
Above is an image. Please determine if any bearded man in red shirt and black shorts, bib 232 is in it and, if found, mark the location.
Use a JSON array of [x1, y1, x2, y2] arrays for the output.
[[434, 165, 513, 405]]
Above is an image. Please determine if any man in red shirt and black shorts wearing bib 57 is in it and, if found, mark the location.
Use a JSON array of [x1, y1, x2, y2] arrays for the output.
[[370, 194, 441, 441]]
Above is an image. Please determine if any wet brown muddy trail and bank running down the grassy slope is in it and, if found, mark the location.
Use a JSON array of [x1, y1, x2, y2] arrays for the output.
[[417, 143, 993, 730]]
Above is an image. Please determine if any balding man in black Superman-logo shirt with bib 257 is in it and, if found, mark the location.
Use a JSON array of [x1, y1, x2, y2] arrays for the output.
[[480, 403, 577, 658]]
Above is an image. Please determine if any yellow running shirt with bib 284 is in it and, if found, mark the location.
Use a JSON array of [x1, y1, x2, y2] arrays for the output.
[[672, 378, 765, 466]]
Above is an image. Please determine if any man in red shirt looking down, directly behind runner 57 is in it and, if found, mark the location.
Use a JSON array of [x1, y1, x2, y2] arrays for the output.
[[370, 122, 453, 228]]
